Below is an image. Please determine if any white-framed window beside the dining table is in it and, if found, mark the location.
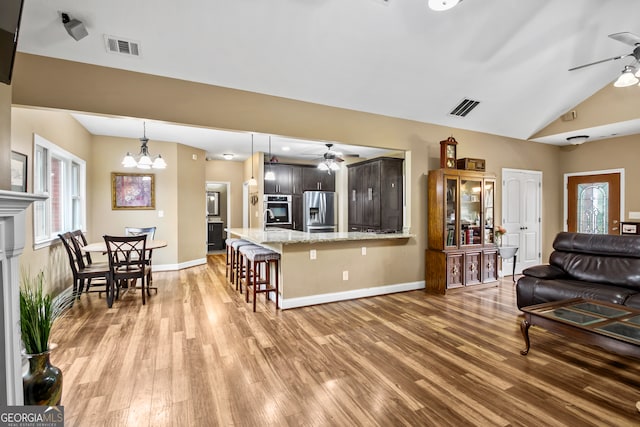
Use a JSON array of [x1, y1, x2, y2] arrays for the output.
[[33, 135, 86, 248]]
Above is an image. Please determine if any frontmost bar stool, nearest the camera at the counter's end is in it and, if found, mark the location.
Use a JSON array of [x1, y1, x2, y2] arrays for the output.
[[240, 246, 280, 312]]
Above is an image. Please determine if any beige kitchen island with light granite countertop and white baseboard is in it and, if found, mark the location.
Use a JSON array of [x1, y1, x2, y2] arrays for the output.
[[226, 228, 424, 309]]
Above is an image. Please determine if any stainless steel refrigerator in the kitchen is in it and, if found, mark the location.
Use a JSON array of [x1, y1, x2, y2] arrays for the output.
[[302, 191, 337, 233]]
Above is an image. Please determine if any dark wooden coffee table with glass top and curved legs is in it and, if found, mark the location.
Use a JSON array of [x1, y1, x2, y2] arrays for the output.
[[520, 298, 640, 358]]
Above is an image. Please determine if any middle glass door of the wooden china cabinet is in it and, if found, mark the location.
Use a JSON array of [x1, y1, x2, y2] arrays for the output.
[[460, 179, 482, 245]]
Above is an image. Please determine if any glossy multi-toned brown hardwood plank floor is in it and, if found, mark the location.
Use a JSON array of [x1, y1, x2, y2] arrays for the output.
[[51, 255, 640, 427]]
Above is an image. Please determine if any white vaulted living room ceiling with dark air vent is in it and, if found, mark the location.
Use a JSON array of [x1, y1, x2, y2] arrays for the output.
[[18, 0, 640, 156]]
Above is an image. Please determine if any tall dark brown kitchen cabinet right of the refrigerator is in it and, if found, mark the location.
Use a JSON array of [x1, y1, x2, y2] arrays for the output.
[[348, 157, 404, 232]]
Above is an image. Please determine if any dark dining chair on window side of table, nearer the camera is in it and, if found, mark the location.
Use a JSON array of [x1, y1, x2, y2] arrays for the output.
[[58, 232, 113, 307]]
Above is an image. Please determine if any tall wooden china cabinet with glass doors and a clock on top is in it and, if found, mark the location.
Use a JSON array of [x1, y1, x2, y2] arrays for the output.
[[425, 169, 498, 294]]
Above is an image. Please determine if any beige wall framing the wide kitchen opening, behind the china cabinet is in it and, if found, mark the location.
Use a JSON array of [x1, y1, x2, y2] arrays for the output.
[[8, 54, 562, 290]]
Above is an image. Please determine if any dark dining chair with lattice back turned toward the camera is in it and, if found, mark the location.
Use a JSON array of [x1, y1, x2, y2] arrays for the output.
[[103, 234, 158, 305]]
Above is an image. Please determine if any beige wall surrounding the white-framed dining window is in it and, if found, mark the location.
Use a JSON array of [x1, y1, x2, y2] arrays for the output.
[[11, 108, 93, 292]]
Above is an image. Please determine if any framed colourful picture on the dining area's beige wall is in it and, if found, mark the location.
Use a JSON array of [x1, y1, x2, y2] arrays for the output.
[[111, 172, 156, 210]]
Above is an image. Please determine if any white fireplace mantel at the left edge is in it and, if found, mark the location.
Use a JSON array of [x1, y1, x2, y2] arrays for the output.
[[0, 190, 47, 405]]
